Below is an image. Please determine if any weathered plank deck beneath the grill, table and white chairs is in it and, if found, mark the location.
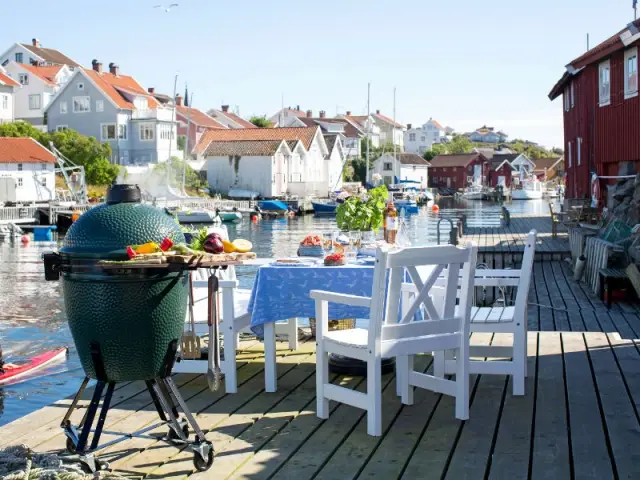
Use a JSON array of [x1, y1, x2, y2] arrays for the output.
[[0, 261, 640, 480]]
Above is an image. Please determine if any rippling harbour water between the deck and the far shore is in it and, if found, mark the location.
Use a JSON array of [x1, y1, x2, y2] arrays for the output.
[[0, 199, 548, 425]]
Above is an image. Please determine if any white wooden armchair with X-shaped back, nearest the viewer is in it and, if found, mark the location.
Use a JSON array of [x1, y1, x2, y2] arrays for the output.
[[311, 244, 477, 436]]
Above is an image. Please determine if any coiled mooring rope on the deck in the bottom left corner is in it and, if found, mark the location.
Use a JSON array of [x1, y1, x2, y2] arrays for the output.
[[0, 445, 126, 480]]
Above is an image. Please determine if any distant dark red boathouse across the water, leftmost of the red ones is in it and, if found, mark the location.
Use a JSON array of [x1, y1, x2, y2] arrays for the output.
[[429, 152, 489, 189]]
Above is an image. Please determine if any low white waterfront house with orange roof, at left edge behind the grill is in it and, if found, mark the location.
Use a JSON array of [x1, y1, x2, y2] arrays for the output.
[[0, 137, 56, 203]]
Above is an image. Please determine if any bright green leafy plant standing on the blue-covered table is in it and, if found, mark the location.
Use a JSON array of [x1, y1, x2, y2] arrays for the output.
[[336, 185, 389, 231]]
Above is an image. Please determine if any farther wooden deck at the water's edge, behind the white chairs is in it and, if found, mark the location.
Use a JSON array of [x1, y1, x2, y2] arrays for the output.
[[463, 213, 571, 258]]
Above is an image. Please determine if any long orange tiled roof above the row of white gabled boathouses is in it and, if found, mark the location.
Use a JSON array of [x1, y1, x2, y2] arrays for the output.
[[194, 127, 320, 154]]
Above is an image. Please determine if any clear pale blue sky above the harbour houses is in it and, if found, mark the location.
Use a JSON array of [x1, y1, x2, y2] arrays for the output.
[[0, 0, 633, 147]]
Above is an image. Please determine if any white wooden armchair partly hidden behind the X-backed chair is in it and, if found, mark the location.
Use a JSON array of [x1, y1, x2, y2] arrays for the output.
[[428, 230, 537, 395]]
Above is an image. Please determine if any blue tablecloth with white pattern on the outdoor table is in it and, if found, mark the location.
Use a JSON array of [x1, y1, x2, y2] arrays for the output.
[[249, 263, 373, 337]]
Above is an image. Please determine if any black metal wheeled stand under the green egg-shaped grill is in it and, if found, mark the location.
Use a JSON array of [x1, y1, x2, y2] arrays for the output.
[[60, 340, 214, 473]]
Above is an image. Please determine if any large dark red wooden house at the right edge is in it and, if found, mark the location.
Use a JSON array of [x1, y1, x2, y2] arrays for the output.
[[549, 20, 640, 198]]
